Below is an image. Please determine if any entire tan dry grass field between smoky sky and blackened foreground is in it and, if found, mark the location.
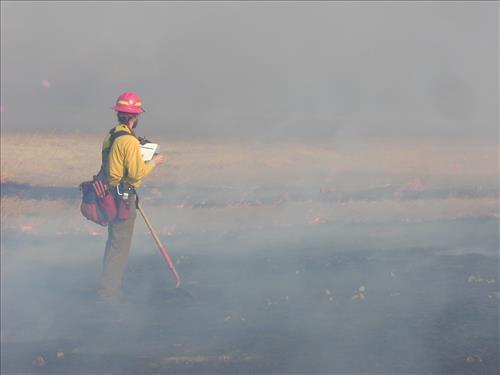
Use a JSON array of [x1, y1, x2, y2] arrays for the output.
[[1, 133, 498, 233]]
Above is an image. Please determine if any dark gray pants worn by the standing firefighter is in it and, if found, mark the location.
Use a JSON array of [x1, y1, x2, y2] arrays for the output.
[[97, 194, 137, 302]]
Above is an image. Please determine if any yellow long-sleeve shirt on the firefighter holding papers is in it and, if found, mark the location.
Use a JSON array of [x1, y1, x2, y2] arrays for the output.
[[102, 124, 155, 187]]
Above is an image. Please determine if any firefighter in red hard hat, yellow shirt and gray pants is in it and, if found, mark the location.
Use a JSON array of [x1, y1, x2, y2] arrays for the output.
[[97, 92, 165, 303]]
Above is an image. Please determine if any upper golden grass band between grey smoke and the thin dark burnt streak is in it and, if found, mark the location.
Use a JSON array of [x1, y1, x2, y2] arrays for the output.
[[1, 133, 499, 188]]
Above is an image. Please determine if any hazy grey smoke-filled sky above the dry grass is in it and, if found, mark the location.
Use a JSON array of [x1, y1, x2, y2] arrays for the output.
[[1, 1, 499, 140]]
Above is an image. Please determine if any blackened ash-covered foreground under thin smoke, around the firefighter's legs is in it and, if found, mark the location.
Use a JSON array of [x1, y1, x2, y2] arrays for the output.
[[2, 206, 500, 374]]
